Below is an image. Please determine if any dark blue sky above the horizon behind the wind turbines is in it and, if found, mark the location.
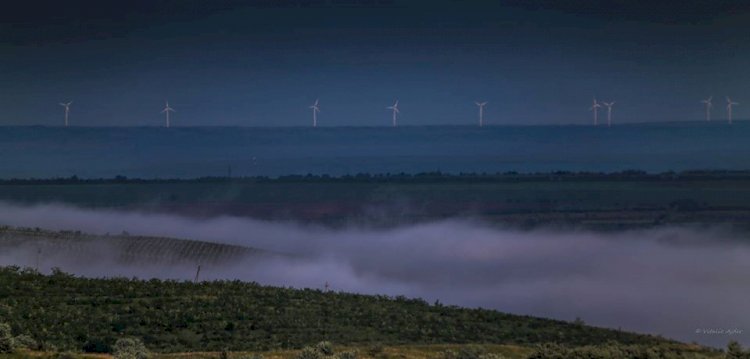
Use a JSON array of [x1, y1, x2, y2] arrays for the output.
[[0, 0, 750, 126]]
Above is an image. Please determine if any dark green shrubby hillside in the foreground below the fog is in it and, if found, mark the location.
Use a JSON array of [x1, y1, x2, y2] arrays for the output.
[[0, 267, 688, 352]]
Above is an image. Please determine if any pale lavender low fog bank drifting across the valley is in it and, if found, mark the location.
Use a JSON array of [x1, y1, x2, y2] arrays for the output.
[[0, 204, 750, 346]]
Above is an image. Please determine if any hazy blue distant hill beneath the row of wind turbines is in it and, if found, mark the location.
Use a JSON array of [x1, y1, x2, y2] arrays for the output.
[[0, 121, 750, 179]]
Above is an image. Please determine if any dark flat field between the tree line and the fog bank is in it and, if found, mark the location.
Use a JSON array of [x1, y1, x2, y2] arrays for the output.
[[0, 172, 750, 229]]
